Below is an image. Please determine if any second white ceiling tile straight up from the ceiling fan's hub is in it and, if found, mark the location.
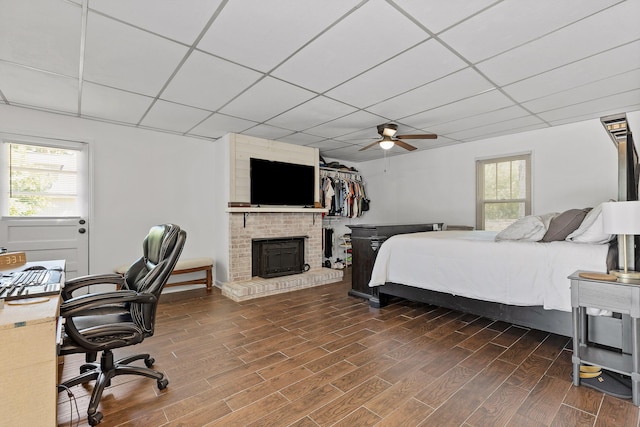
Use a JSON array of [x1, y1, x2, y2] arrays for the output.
[[327, 39, 466, 106]]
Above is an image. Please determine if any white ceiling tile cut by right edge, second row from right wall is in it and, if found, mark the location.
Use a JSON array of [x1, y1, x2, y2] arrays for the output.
[[523, 68, 640, 113]]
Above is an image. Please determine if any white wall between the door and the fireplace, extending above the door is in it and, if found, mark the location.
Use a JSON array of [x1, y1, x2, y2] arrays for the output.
[[0, 105, 216, 273]]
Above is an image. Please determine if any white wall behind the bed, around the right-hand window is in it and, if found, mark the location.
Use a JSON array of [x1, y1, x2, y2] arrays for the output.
[[354, 112, 640, 226]]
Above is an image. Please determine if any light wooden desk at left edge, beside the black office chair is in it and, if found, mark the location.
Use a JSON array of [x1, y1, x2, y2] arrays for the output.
[[0, 261, 65, 426]]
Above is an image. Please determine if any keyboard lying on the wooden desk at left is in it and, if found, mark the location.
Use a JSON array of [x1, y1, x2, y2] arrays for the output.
[[0, 270, 62, 301]]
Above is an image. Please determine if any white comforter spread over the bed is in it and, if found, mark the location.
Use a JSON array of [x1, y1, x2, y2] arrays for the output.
[[369, 231, 608, 311]]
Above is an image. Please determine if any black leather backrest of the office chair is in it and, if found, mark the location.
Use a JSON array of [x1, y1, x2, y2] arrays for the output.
[[125, 224, 187, 335]]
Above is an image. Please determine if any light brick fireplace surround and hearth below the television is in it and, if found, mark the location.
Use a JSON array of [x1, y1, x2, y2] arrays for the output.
[[222, 210, 342, 301]]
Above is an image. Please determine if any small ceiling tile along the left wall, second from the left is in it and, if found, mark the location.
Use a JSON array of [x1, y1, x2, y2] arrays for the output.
[[81, 82, 153, 124]]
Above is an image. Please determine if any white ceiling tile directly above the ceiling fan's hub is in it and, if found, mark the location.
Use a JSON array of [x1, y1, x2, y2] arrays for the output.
[[367, 68, 493, 120]]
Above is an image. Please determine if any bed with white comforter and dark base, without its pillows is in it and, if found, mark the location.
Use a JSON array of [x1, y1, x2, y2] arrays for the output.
[[369, 212, 617, 344]]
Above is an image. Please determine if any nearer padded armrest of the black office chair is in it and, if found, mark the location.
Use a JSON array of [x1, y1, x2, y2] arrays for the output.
[[60, 290, 157, 317]]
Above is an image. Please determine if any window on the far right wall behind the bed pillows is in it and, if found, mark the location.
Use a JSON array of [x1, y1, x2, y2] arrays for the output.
[[476, 154, 531, 231]]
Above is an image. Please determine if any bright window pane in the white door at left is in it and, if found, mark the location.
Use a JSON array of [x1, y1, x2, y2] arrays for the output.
[[5, 142, 80, 217]]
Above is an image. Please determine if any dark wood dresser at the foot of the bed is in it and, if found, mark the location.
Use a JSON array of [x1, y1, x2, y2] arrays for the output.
[[347, 222, 443, 299]]
